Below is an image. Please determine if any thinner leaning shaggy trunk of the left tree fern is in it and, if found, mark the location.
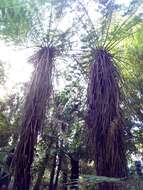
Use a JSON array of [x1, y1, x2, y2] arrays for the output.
[[13, 47, 53, 190]]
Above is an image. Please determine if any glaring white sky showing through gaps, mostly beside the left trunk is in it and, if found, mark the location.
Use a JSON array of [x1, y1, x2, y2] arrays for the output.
[[0, 0, 133, 98]]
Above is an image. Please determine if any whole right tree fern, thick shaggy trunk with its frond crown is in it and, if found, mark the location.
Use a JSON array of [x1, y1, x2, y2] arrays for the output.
[[71, 1, 140, 190]]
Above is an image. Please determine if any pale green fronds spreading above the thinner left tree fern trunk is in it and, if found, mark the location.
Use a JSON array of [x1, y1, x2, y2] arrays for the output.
[[0, 0, 73, 50]]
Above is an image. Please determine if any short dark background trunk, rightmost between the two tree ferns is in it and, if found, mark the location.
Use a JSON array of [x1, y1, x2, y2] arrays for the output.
[[70, 158, 79, 190]]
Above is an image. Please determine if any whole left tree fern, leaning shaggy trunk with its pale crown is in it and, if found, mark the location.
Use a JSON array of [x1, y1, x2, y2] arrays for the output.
[[3, 2, 73, 190]]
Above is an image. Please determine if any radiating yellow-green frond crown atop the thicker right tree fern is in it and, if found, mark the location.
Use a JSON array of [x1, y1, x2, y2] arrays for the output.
[[77, 1, 143, 51]]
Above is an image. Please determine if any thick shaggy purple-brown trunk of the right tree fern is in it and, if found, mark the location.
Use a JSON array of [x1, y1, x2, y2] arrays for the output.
[[86, 49, 127, 190]]
